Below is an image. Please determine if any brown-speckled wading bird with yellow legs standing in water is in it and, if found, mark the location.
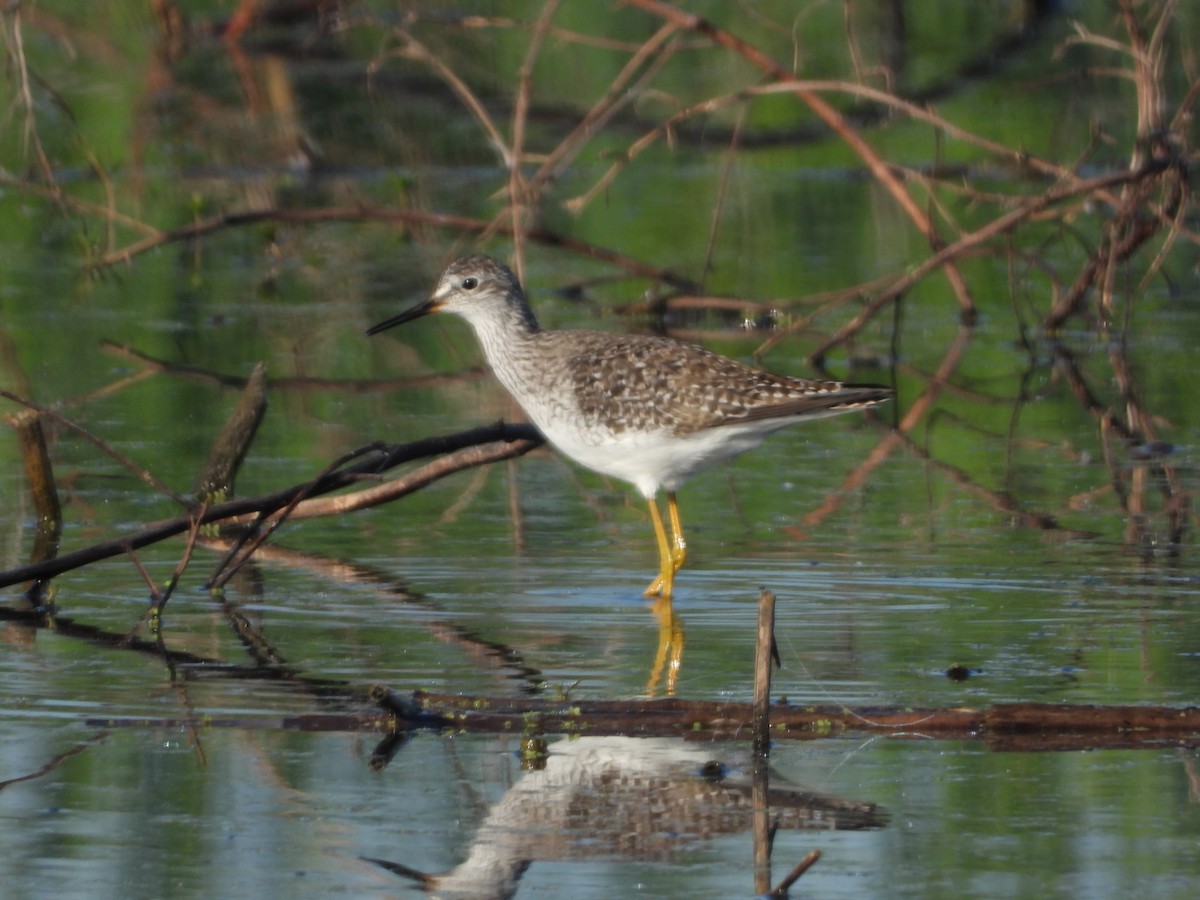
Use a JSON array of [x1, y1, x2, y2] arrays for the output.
[[367, 256, 892, 600]]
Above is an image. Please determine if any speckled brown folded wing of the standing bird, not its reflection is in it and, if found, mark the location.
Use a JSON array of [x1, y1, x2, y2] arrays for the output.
[[566, 332, 890, 434]]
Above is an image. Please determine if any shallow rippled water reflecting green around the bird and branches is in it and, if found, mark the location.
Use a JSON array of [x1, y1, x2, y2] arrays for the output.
[[0, 0, 1200, 898]]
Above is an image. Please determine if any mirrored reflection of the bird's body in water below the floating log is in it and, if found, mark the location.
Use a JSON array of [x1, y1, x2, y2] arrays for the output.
[[370, 737, 887, 899]]
